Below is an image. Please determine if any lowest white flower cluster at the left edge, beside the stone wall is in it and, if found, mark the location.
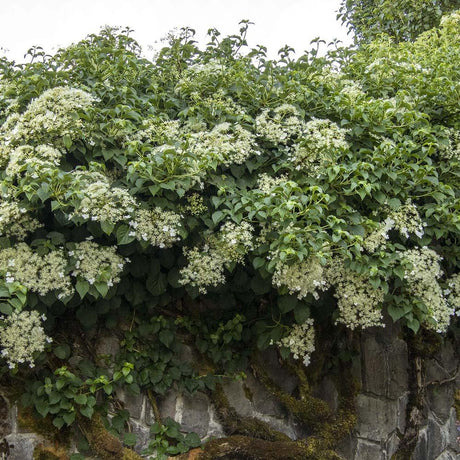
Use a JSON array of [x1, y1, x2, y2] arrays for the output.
[[0, 311, 52, 369]]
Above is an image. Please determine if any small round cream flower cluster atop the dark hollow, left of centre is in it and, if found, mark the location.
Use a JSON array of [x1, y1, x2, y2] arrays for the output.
[[129, 207, 182, 248]]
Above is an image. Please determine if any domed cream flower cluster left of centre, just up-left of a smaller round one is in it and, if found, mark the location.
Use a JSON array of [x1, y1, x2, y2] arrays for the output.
[[71, 179, 137, 223]]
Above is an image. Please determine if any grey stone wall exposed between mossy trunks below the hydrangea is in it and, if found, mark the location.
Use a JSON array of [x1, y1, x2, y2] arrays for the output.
[[0, 326, 460, 460]]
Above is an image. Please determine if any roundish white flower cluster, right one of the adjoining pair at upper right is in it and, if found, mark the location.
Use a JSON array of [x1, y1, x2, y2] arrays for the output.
[[292, 120, 350, 172]]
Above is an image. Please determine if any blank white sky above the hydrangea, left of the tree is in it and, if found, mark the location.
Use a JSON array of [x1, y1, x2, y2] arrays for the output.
[[0, 0, 351, 61]]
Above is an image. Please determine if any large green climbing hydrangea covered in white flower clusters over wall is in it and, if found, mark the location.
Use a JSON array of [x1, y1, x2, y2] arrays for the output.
[[0, 13, 460, 444]]
